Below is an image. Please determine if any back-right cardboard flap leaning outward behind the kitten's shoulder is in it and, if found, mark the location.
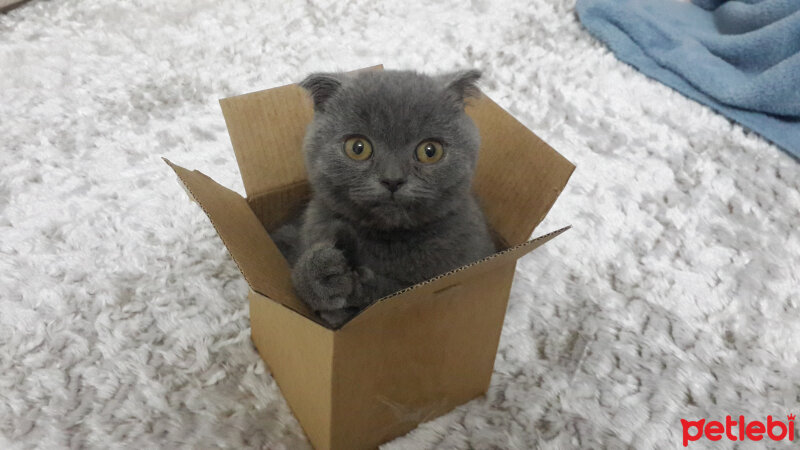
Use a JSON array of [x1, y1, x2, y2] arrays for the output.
[[467, 95, 575, 246]]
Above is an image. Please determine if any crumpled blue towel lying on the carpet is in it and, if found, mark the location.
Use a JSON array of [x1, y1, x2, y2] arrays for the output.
[[577, 0, 800, 158]]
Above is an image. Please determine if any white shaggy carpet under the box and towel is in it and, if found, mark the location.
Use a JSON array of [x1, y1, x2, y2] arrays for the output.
[[0, 0, 800, 449]]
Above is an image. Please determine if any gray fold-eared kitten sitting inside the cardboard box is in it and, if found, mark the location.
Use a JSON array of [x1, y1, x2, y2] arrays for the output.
[[274, 70, 496, 327]]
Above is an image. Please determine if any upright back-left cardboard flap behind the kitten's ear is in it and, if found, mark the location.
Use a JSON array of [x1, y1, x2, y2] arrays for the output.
[[219, 66, 383, 198]]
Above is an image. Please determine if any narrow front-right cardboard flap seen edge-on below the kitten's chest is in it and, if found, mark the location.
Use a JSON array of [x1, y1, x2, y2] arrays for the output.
[[342, 226, 571, 328]]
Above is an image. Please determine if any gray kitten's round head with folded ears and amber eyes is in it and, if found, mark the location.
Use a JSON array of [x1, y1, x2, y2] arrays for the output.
[[301, 70, 480, 230]]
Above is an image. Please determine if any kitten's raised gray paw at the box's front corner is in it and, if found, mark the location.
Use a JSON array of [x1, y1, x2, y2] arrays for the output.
[[292, 244, 356, 311]]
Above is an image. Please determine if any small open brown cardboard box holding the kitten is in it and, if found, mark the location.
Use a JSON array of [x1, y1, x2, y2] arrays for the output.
[[167, 67, 574, 449]]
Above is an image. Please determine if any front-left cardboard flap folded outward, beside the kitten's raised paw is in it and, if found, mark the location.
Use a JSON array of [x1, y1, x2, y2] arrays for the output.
[[164, 158, 313, 320]]
